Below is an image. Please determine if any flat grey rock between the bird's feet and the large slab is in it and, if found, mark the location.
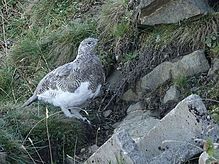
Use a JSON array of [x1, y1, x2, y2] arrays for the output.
[[114, 102, 159, 142]]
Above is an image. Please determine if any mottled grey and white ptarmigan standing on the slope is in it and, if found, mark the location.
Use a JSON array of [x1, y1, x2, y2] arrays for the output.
[[22, 38, 105, 122]]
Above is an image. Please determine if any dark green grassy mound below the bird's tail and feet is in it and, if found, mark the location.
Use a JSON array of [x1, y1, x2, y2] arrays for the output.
[[0, 104, 87, 163]]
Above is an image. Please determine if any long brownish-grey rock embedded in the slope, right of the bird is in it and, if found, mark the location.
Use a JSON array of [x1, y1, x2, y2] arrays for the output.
[[140, 50, 210, 91]]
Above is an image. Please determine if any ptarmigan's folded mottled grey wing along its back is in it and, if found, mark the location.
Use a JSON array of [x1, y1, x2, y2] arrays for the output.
[[35, 63, 80, 95]]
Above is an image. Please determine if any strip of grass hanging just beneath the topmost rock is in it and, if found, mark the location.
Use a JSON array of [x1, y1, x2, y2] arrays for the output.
[[140, 13, 219, 50]]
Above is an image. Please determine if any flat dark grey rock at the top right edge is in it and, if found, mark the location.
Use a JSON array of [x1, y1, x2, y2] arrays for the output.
[[138, 0, 212, 25]]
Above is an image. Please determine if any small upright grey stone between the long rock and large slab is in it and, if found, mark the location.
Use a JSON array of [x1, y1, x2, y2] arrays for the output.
[[163, 85, 180, 104]]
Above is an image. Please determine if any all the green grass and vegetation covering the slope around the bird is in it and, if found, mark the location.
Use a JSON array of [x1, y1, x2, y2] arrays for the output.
[[0, 0, 219, 163]]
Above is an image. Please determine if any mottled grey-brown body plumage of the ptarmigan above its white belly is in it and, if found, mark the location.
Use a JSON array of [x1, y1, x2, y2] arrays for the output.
[[35, 54, 105, 95]]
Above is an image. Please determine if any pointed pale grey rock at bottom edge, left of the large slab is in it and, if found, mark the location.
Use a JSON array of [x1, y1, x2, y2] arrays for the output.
[[85, 130, 145, 164]]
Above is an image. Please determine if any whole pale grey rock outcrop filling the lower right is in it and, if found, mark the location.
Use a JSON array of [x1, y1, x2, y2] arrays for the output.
[[85, 95, 219, 164]]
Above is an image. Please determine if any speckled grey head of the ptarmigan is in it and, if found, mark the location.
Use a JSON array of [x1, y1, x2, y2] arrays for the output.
[[78, 38, 98, 55]]
